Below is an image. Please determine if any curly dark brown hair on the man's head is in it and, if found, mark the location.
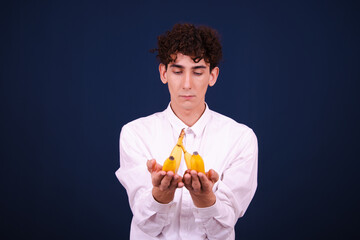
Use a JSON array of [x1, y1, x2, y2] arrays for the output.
[[151, 23, 222, 71]]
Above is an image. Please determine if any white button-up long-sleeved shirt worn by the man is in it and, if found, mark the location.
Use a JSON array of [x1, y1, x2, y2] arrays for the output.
[[116, 104, 258, 240]]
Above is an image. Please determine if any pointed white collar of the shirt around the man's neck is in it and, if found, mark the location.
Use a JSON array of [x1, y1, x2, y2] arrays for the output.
[[165, 103, 210, 136]]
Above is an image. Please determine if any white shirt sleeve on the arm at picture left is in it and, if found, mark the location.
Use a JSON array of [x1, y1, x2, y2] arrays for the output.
[[116, 125, 176, 237]]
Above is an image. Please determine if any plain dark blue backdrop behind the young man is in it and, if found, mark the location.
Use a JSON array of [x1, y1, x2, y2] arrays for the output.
[[0, 0, 360, 239]]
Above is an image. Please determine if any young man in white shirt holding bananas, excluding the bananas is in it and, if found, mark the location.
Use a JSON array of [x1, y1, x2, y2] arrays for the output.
[[116, 24, 258, 240]]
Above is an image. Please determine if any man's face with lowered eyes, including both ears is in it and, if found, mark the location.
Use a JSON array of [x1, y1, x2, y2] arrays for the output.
[[159, 53, 219, 113]]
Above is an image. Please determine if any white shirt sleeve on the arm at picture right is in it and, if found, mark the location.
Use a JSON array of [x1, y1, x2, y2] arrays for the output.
[[194, 129, 258, 240]]
